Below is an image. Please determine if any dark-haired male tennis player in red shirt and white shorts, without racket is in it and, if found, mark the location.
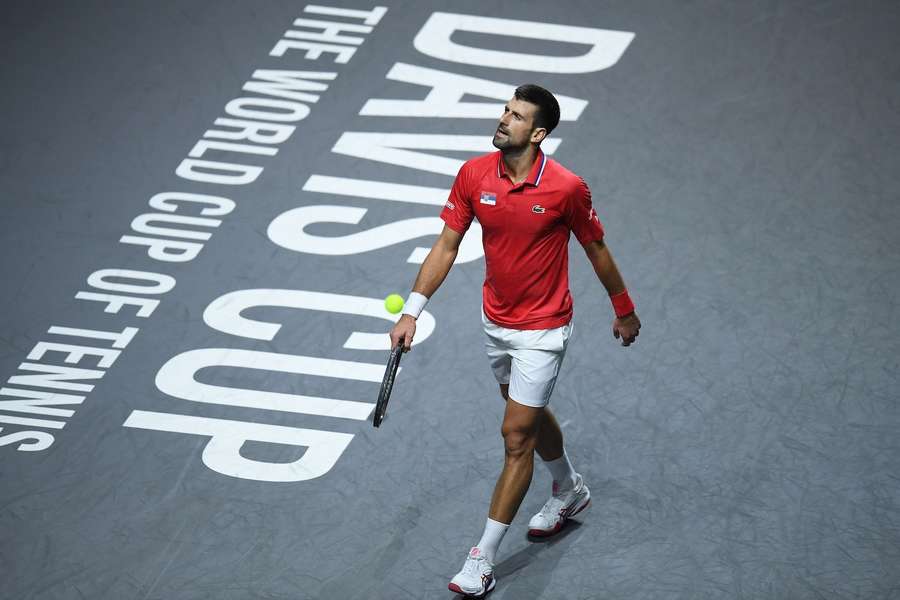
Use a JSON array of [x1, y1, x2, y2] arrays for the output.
[[390, 85, 641, 597]]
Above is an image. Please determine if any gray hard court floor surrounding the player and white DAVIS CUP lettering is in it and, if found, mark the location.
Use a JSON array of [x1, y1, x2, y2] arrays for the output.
[[0, 0, 900, 600]]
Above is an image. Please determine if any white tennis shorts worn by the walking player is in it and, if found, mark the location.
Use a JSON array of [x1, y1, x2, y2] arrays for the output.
[[481, 311, 573, 407]]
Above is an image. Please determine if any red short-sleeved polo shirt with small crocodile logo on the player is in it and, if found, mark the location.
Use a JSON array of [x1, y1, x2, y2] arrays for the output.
[[441, 151, 603, 329]]
